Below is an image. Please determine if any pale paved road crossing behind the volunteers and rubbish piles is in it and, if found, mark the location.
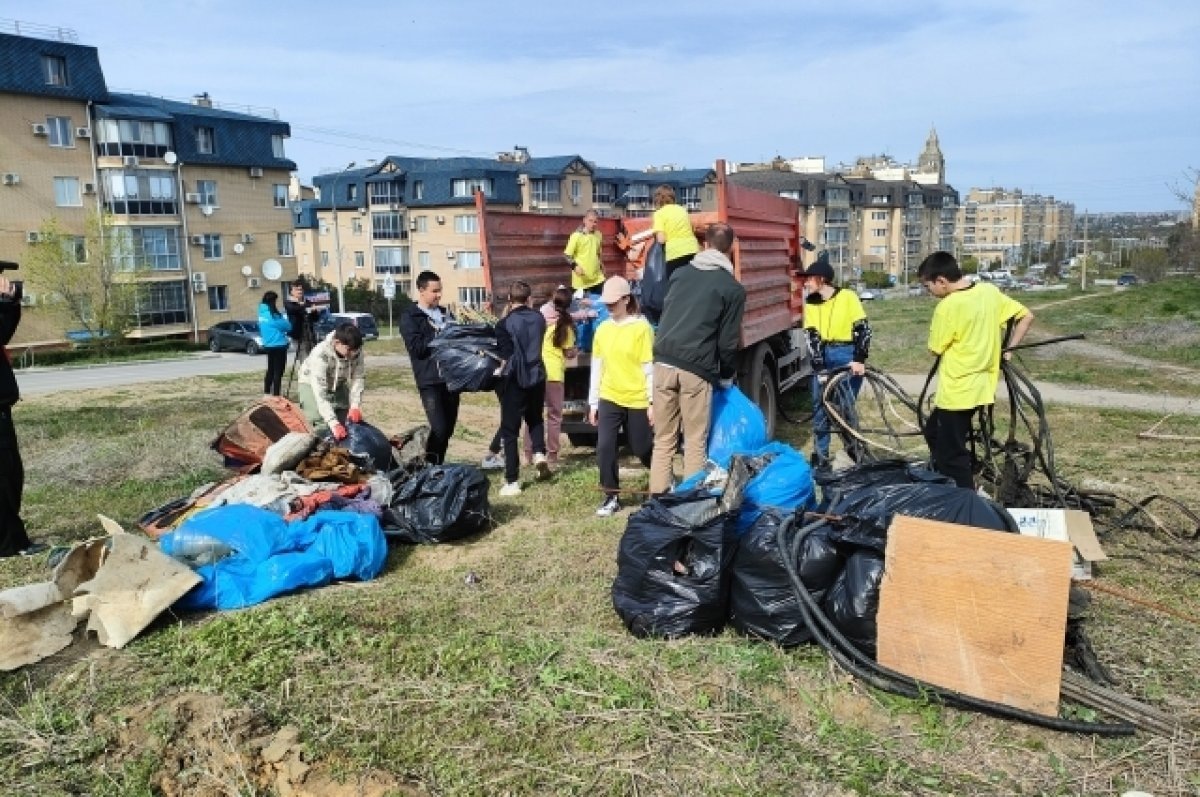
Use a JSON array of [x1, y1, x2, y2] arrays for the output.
[[17, 353, 1200, 415]]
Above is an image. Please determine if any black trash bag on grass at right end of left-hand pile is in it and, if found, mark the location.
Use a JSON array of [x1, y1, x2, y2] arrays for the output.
[[383, 465, 492, 544]]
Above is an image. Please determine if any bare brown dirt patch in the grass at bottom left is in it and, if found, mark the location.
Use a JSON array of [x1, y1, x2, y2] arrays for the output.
[[97, 693, 417, 797]]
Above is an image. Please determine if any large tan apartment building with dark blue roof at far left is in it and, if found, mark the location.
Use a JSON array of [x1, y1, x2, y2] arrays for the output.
[[0, 23, 296, 344]]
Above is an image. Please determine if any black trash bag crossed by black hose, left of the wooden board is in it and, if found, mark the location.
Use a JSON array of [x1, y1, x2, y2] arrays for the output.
[[730, 509, 845, 647]]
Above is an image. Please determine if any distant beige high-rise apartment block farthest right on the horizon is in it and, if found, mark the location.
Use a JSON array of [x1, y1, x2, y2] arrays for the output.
[[955, 187, 1075, 268]]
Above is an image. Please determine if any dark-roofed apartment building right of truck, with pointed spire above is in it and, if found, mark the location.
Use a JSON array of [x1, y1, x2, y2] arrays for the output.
[[730, 130, 959, 288]]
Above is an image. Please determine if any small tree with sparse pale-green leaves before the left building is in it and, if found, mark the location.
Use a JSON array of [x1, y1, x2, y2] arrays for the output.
[[25, 214, 140, 349]]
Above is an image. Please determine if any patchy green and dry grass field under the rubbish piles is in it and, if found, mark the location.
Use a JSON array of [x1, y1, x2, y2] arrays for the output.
[[0, 286, 1200, 797]]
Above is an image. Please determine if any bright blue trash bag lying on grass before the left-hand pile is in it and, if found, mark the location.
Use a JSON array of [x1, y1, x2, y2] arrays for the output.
[[158, 504, 388, 610]]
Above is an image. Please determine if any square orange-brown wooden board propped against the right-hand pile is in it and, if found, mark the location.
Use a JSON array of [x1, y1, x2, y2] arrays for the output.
[[877, 515, 1073, 717]]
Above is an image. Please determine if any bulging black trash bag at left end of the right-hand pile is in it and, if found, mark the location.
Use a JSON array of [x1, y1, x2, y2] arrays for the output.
[[612, 490, 737, 639]]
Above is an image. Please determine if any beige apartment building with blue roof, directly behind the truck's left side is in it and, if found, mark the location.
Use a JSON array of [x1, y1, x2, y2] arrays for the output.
[[302, 148, 716, 305]]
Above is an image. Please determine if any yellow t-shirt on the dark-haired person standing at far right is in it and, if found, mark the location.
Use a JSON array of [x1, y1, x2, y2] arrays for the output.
[[929, 282, 1028, 409]]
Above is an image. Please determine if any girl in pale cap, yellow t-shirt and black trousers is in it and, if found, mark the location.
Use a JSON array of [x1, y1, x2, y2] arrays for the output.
[[588, 277, 654, 517]]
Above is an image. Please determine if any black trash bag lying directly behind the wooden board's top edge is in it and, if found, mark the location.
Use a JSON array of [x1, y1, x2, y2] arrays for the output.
[[829, 483, 1019, 552]]
